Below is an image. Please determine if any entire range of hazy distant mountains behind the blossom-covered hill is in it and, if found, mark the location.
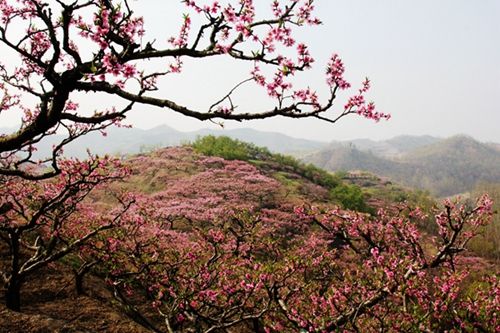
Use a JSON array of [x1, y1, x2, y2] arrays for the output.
[[6, 125, 500, 196]]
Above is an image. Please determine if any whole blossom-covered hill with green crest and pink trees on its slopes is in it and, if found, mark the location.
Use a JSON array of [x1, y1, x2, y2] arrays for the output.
[[0, 136, 498, 332]]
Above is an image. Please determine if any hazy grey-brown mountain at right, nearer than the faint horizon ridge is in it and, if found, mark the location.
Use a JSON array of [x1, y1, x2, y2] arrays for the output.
[[303, 136, 500, 196]]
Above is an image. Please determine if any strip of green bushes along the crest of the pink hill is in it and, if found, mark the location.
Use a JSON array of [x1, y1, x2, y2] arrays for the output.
[[191, 135, 371, 212]]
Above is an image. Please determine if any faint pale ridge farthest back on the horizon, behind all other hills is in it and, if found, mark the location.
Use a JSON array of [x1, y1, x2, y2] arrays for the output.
[[0, 124, 500, 158]]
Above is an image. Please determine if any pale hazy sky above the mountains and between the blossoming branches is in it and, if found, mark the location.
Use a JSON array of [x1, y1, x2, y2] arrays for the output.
[[0, 0, 500, 142]]
